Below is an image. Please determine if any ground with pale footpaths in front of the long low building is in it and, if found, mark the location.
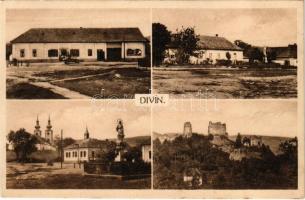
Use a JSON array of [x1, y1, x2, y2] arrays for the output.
[[7, 62, 150, 99]]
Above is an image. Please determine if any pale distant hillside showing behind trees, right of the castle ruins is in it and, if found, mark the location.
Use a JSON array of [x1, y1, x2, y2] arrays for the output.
[[229, 135, 291, 155]]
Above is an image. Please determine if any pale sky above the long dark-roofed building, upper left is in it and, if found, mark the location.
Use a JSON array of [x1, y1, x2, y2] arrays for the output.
[[6, 9, 151, 42]]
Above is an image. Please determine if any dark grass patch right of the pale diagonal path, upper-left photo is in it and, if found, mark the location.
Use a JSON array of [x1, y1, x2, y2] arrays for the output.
[[54, 68, 150, 98]]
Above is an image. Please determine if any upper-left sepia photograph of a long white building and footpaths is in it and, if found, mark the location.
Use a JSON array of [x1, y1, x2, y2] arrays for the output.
[[5, 9, 151, 99]]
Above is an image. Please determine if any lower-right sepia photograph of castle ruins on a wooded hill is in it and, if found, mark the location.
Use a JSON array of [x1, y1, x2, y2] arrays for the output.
[[153, 100, 298, 190]]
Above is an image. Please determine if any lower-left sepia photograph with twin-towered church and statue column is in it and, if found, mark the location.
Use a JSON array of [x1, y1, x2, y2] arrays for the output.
[[6, 101, 152, 189]]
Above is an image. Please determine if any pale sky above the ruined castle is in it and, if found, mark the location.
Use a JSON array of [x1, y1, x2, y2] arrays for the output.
[[152, 100, 297, 137]]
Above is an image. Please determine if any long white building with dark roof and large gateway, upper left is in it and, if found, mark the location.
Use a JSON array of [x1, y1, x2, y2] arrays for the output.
[[11, 27, 147, 62]]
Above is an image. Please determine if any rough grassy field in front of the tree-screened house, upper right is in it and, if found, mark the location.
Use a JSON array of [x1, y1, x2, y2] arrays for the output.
[[153, 68, 297, 98]]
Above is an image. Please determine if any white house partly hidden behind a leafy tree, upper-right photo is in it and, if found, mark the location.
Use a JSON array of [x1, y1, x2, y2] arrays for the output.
[[164, 35, 243, 64]]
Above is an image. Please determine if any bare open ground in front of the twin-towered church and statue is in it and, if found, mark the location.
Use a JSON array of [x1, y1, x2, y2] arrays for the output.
[[6, 162, 151, 189]]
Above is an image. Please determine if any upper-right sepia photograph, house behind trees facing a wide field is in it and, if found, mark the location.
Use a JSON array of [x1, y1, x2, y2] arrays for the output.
[[152, 8, 298, 99]]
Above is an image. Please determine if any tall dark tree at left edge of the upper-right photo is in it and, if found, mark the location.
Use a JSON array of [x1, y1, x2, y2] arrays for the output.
[[152, 23, 171, 66]]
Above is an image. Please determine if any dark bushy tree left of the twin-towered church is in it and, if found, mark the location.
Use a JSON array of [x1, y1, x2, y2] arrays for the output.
[[7, 128, 38, 162]]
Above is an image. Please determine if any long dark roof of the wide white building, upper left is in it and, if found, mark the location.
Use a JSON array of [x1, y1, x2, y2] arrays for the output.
[[11, 28, 147, 43]]
